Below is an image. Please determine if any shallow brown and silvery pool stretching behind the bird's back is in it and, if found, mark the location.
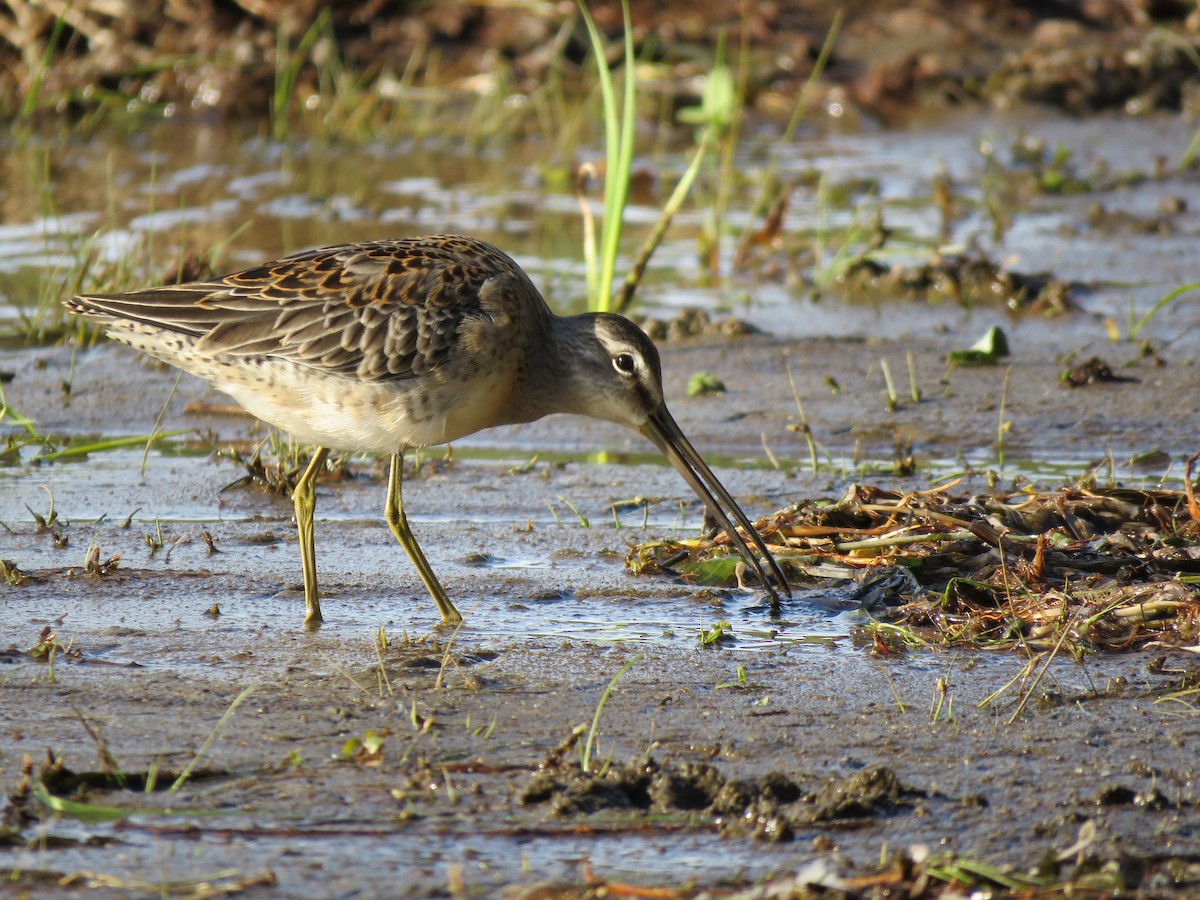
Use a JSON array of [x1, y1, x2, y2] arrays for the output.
[[0, 112, 1200, 349]]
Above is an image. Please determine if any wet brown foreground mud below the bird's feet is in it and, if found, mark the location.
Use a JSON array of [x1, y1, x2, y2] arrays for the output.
[[5, 632, 1198, 896]]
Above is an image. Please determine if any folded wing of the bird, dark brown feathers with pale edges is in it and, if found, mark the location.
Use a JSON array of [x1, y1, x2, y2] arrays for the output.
[[67, 235, 523, 380]]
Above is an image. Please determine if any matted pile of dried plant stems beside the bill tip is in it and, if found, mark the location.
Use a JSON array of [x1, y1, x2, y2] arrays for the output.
[[626, 484, 1200, 653]]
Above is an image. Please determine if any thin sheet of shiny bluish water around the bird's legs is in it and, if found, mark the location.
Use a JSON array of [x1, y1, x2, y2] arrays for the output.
[[0, 450, 848, 670]]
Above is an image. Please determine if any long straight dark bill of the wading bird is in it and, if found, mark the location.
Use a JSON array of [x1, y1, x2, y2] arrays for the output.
[[641, 403, 792, 605]]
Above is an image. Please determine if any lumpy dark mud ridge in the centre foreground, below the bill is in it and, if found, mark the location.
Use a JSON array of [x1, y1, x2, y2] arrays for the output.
[[518, 758, 919, 841]]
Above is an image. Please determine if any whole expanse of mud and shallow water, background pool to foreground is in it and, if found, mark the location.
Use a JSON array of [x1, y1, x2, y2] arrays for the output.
[[0, 112, 1200, 896]]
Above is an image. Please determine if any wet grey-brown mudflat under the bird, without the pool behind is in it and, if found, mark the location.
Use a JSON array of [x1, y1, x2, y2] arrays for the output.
[[0, 326, 1200, 896]]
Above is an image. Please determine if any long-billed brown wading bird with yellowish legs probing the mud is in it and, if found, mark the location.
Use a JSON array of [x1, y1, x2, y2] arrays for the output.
[[65, 235, 788, 624]]
